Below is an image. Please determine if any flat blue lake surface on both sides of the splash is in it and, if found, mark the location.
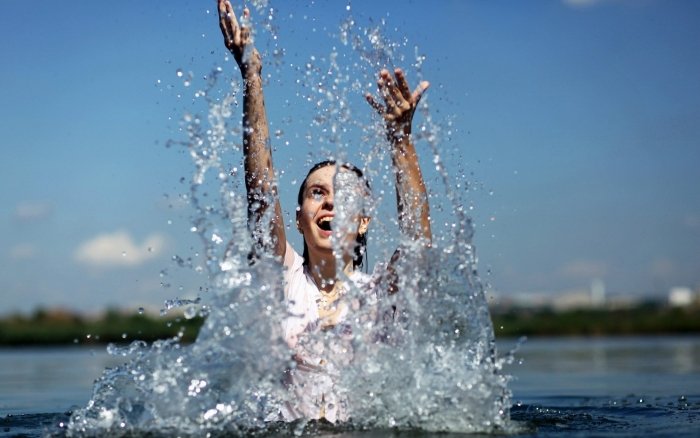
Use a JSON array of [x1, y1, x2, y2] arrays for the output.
[[0, 336, 700, 436]]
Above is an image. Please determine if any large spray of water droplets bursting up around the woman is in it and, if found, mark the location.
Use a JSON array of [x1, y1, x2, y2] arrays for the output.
[[68, 2, 512, 436]]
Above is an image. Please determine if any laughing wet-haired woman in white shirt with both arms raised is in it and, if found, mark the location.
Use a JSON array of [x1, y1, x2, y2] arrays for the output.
[[218, 0, 432, 422]]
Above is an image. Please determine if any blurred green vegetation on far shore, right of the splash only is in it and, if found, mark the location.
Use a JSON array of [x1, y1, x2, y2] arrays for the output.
[[491, 303, 700, 337]]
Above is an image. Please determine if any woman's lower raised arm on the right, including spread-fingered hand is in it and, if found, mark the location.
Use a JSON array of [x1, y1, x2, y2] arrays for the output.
[[365, 68, 432, 245]]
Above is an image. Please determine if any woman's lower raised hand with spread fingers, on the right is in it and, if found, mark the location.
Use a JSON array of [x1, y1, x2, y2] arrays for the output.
[[365, 68, 430, 141]]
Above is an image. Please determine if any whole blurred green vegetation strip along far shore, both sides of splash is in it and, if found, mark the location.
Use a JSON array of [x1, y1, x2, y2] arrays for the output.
[[0, 303, 700, 346]]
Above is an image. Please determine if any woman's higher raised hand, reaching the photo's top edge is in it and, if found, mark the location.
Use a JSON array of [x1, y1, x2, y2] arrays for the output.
[[218, 0, 262, 75]]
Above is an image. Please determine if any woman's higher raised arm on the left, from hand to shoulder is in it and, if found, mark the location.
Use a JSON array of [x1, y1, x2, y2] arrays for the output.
[[218, 0, 287, 259]]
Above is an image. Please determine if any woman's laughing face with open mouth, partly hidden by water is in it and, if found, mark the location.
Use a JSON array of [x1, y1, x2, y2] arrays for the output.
[[297, 165, 369, 259]]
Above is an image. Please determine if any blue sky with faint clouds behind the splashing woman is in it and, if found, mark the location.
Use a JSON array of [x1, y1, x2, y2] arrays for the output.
[[0, 0, 700, 314]]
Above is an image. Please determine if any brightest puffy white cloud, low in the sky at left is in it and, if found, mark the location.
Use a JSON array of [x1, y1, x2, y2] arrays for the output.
[[74, 230, 165, 268]]
